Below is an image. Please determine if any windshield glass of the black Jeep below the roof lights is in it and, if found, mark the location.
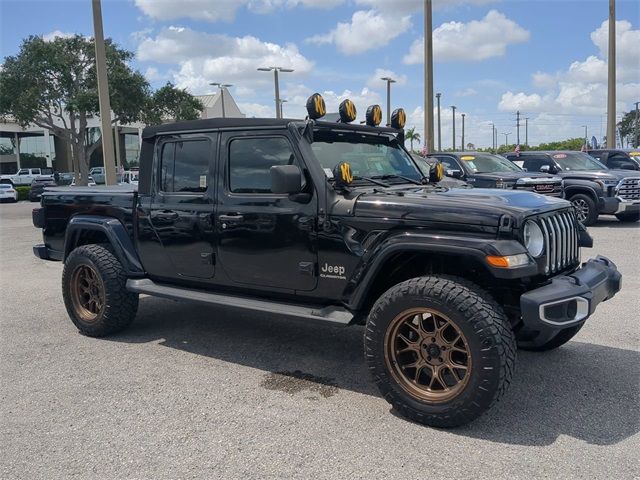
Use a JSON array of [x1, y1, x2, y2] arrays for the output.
[[311, 131, 422, 183]]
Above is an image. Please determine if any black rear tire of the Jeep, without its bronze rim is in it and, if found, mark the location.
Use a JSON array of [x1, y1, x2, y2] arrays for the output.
[[62, 245, 138, 337]]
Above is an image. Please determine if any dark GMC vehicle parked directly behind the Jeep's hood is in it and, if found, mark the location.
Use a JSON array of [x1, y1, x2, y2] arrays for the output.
[[429, 152, 563, 197]]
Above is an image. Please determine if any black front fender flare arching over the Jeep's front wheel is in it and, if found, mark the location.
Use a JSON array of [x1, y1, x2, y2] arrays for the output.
[[347, 232, 538, 310]]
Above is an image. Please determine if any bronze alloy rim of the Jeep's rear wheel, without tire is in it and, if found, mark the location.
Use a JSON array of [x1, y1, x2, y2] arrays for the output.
[[71, 264, 105, 323]]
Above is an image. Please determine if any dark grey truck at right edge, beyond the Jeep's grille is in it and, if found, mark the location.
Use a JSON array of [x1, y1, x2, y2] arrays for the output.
[[505, 151, 640, 225]]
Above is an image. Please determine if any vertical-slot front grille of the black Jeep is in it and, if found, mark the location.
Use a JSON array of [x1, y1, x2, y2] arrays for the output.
[[539, 210, 580, 273]]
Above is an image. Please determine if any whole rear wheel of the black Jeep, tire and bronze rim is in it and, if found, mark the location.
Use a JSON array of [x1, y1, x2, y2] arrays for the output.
[[62, 245, 138, 337]]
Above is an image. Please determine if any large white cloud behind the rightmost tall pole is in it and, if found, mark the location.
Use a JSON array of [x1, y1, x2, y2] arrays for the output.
[[498, 20, 640, 115]]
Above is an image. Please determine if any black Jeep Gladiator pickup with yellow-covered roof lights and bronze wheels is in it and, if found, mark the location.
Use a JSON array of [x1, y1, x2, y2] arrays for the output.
[[33, 94, 621, 427]]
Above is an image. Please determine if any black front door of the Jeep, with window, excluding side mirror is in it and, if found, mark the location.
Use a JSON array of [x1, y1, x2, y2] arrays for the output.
[[216, 131, 318, 291]]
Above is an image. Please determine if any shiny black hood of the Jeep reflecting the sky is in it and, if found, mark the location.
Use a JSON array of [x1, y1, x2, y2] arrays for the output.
[[353, 187, 570, 227]]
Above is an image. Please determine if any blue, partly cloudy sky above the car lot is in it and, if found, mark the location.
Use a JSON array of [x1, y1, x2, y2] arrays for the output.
[[0, 0, 640, 148]]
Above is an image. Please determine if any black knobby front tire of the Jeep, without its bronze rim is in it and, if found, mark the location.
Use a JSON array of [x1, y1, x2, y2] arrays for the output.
[[365, 275, 516, 427]]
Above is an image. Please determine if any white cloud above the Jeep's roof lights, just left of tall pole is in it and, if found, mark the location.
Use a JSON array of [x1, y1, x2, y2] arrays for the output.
[[307, 10, 411, 55]]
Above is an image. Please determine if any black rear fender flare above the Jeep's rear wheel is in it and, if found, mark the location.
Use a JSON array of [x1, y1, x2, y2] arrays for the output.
[[62, 215, 145, 277]]
